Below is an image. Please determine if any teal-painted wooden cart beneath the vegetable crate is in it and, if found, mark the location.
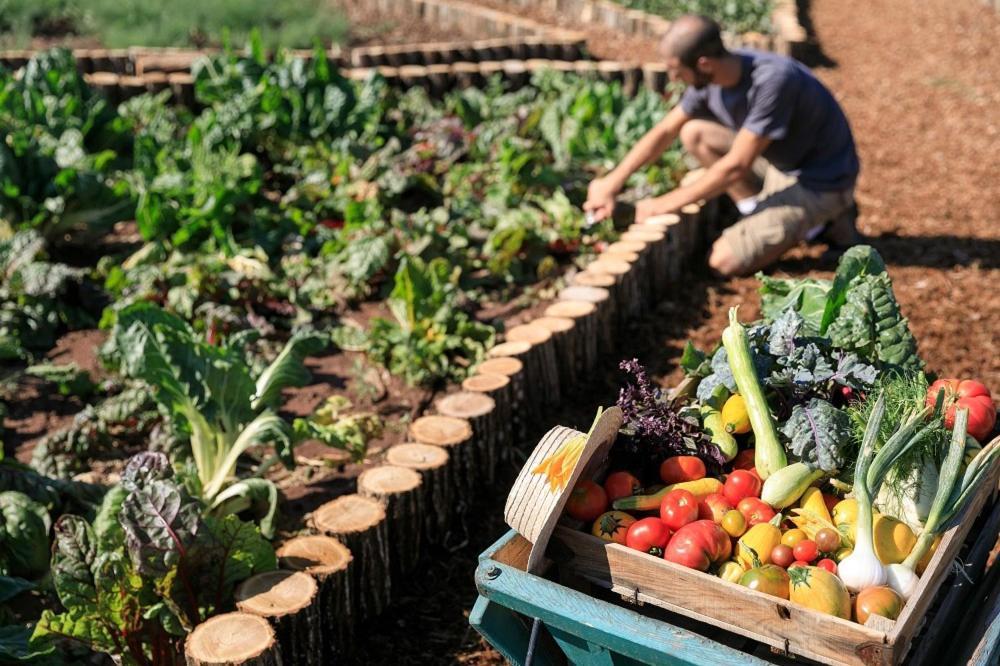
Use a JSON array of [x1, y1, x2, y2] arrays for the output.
[[470, 492, 1000, 666]]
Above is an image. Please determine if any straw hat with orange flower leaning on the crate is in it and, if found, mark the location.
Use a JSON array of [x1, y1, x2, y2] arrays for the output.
[[504, 407, 622, 573]]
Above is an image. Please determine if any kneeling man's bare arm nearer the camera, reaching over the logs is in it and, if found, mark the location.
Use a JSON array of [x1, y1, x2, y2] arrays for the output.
[[635, 130, 771, 222]]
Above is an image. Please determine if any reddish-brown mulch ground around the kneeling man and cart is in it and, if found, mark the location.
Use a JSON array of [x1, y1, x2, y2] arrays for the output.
[[348, 0, 1000, 665]]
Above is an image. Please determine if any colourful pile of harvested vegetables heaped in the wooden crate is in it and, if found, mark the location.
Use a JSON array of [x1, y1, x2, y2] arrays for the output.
[[560, 246, 1000, 624]]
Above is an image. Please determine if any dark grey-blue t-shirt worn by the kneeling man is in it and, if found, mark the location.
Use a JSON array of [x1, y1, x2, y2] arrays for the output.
[[681, 49, 858, 191]]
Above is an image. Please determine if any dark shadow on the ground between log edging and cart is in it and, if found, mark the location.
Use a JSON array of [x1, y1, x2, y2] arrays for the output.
[[347, 275, 715, 666]]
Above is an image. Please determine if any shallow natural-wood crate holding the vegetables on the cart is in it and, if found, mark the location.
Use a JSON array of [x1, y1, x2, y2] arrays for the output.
[[550, 466, 998, 666]]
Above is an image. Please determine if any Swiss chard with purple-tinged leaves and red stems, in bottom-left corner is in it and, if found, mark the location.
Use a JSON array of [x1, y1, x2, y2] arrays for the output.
[[33, 453, 277, 666]]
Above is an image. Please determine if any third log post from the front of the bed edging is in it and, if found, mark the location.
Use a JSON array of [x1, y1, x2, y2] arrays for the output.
[[276, 534, 354, 658]]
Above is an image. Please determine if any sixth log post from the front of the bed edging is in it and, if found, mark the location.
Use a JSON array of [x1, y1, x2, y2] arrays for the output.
[[385, 442, 454, 544]]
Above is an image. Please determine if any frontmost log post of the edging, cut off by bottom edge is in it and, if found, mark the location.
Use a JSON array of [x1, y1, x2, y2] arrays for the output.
[[184, 613, 282, 666]]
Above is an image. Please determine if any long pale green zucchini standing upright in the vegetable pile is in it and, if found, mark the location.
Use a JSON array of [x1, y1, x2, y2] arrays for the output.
[[722, 307, 788, 479]]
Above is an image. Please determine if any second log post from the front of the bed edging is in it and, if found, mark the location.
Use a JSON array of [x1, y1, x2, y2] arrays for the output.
[[234, 569, 326, 664]]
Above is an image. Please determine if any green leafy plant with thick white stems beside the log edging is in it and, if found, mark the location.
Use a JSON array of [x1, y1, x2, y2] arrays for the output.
[[112, 303, 322, 534]]
